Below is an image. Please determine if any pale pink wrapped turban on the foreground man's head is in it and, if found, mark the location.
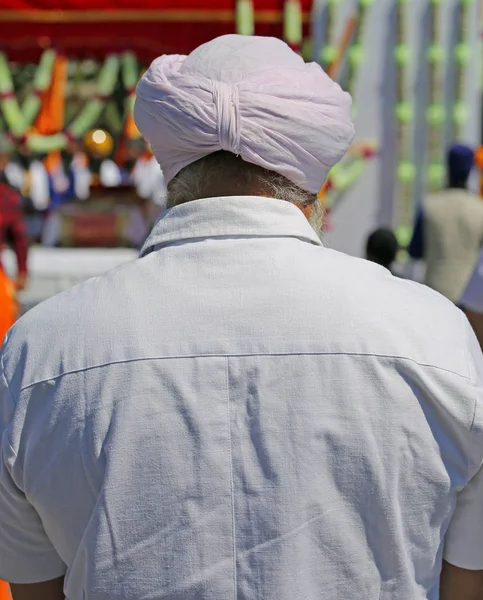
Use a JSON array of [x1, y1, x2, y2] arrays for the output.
[[134, 35, 354, 193]]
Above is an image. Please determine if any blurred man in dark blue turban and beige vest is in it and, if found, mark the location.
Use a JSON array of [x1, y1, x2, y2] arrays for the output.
[[409, 145, 483, 303]]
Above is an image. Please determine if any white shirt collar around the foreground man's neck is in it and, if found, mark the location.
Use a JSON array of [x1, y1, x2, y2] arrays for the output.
[[141, 196, 322, 256]]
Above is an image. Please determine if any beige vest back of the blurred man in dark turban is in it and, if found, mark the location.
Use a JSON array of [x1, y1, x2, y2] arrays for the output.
[[424, 189, 483, 302]]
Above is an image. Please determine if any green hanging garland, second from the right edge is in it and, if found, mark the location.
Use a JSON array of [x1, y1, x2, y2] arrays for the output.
[[426, 0, 446, 191]]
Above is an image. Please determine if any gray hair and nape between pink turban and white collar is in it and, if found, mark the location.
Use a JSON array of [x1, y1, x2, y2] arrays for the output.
[[167, 151, 318, 208]]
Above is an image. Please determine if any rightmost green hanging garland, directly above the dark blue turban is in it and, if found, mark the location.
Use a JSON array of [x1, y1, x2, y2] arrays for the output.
[[451, 0, 474, 141]]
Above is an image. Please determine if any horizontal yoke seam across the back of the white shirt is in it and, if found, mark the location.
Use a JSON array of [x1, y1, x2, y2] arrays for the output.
[[20, 352, 470, 393]]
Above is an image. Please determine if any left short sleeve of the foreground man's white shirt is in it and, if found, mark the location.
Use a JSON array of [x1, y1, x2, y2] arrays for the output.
[[0, 354, 66, 583]]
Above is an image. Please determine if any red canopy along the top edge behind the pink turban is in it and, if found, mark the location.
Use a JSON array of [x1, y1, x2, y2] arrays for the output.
[[0, 0, 312, 62]]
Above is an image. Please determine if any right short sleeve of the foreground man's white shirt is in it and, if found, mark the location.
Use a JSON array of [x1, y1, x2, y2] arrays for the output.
[[444, 316, 483, 571]]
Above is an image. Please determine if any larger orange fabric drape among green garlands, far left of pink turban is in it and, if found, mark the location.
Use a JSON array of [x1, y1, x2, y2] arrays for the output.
[[35, 55, 68, 173]]
